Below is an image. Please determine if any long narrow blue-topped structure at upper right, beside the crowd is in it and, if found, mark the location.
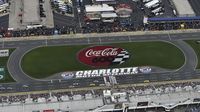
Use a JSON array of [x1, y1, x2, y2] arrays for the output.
[[148, 16, 200, 22]]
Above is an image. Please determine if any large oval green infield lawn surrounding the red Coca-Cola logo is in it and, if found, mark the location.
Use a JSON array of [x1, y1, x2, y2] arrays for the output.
[[21, 42, 185, 78]]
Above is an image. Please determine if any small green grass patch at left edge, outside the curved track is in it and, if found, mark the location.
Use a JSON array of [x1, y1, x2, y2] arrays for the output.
[[0, 49, 14, 83]]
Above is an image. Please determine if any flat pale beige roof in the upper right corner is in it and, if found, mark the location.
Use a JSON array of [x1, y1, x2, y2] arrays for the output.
[[172, 0, 195, 17]]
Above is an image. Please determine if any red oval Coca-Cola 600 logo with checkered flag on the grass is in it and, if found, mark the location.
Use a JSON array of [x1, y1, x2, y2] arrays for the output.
[[78, 46, 130, 67]]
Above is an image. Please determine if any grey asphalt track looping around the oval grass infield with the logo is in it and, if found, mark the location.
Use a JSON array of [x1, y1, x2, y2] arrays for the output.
[[0, 33, 200, 92]]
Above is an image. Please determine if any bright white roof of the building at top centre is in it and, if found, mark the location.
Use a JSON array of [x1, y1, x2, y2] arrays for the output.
[[85, 4, 114, 12]]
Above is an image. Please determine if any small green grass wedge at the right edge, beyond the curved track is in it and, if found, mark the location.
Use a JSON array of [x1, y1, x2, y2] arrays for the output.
[[186, 40, 200, 69]]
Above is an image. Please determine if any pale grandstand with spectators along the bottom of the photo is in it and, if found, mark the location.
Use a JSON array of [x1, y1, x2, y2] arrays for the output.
[[0, 82, 200, 112]]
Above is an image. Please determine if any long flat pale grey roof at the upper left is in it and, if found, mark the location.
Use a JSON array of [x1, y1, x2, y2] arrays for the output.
[[22, 0, 40, 24]]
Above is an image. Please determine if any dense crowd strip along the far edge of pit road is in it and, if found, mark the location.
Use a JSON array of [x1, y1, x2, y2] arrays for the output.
[[0, 21, 200, 37]]
